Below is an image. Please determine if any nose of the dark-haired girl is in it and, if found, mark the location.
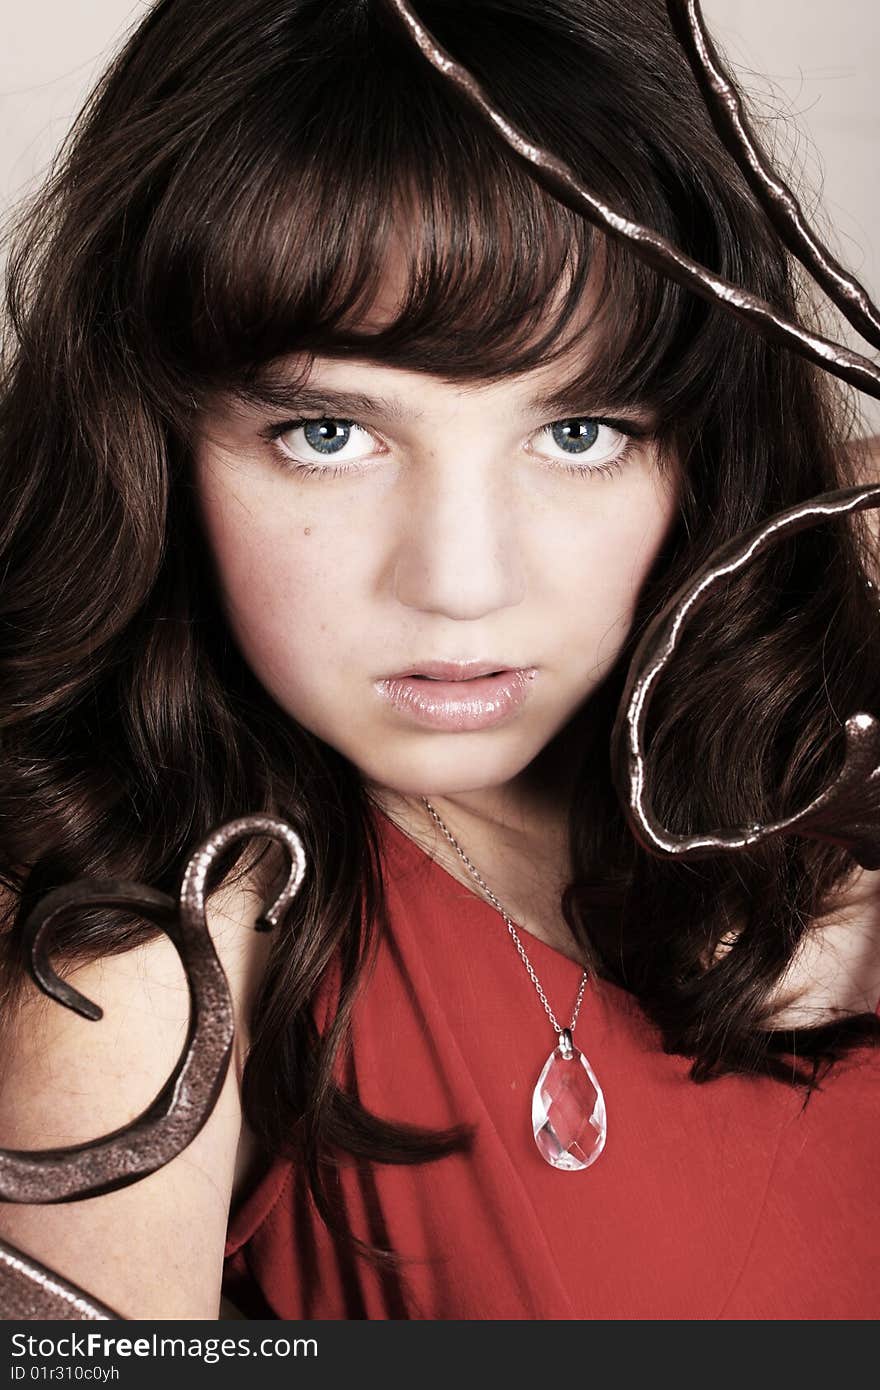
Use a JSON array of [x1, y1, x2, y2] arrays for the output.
[[392, 455, 525, 620]]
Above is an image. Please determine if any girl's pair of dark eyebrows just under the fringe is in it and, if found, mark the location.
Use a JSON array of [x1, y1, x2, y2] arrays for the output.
[[238, 379, 646, 424]]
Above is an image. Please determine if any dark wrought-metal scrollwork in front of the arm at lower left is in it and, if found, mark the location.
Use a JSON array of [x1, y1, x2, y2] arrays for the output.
[[0, 815, 306, 1318]]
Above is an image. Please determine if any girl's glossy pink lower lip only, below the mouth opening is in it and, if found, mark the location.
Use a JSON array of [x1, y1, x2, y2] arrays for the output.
[[377, 666, 538, 731]]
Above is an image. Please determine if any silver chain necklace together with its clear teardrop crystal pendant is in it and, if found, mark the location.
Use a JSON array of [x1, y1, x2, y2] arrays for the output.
[[421, 796, 608, 1173]]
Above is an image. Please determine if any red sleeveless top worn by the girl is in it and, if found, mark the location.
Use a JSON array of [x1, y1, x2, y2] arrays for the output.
[[224, 815, 880, 1321]]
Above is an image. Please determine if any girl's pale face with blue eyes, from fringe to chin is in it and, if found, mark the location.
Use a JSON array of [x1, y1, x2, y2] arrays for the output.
[[195, 332, 676, 795]]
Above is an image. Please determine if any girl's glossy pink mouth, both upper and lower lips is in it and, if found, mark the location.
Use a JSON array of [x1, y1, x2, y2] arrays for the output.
[[375, 662, 538, 733]]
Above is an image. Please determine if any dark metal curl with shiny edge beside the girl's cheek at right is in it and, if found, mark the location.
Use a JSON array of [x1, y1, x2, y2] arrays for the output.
[[612, 484, 880, 869]]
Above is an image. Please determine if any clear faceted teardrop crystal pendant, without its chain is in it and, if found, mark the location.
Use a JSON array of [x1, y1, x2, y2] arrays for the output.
[[531, 1029, 608, 1173]]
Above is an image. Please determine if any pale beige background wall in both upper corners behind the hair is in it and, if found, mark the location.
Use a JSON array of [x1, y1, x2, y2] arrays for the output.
[[0, 0, 880, 428]]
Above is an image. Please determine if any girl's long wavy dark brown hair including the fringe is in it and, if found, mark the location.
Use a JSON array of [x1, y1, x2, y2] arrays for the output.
[[0, 0, 880, 1256]]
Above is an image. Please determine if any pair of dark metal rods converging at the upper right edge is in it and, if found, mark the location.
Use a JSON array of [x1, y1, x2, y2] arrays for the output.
[[385, 0, 880, 399]]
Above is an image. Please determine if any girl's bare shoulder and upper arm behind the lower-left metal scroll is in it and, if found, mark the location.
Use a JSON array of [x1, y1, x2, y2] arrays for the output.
[[0, 861, 270, 1319]]
